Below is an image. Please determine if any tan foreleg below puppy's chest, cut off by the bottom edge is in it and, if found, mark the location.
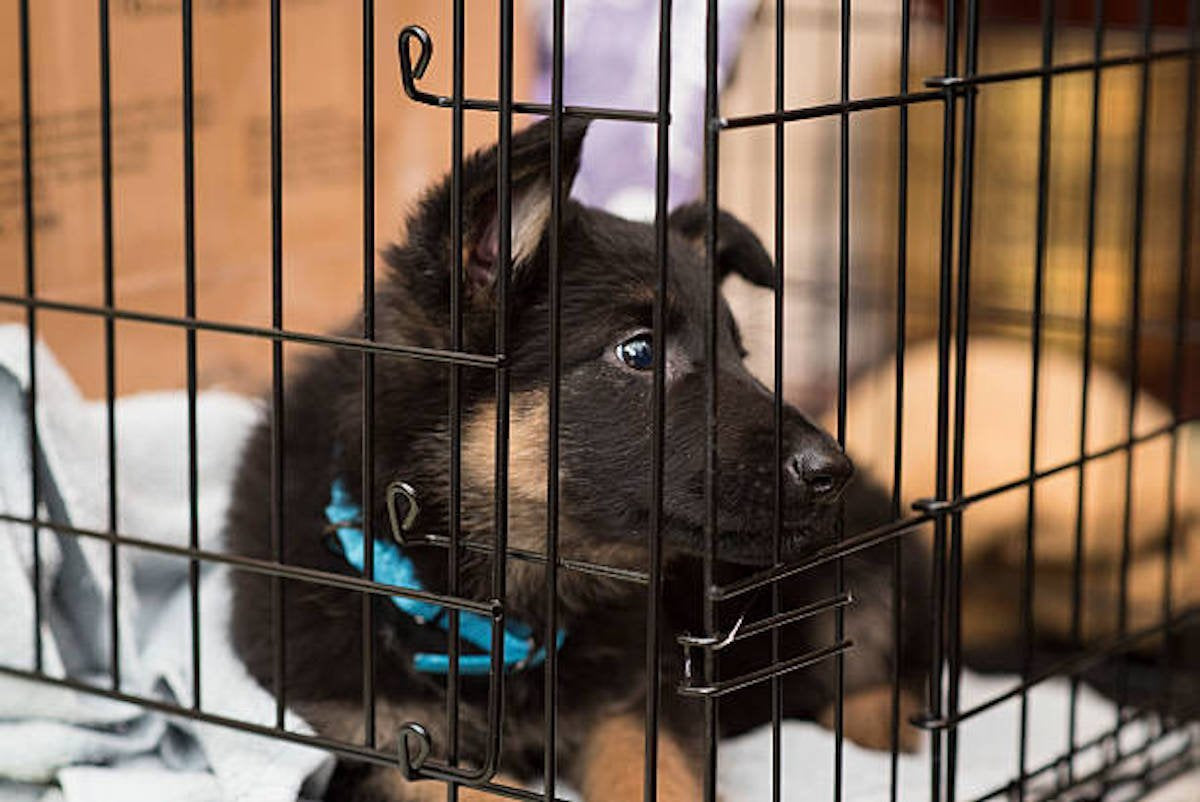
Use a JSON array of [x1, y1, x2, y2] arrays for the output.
[[580, 714, 703, 802]]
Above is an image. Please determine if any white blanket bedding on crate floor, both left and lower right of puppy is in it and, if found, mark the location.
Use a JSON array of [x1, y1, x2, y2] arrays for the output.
[[0, 327, 1182, 802]]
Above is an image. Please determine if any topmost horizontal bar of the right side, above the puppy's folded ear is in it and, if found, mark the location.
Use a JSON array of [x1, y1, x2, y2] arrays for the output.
[[718, 47, 1193, 130]]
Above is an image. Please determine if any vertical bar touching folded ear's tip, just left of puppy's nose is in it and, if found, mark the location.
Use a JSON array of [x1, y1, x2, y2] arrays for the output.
[[770, 0, 787, 802]]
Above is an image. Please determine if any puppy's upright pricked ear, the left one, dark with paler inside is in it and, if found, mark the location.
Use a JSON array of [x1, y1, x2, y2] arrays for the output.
[[409, 118, 588, 298]]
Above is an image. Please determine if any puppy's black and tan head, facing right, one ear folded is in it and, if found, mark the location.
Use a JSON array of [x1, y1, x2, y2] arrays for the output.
[[389, 120, 852, 563]]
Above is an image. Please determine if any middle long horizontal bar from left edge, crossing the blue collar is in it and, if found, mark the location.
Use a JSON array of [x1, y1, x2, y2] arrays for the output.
[[0, 513, 497, 616]]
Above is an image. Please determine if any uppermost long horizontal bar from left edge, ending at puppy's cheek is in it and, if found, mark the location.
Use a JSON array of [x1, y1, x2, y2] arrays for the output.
[[0, 293, 505, 369]]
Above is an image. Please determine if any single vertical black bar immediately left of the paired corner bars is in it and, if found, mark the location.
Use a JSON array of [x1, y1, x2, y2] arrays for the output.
[[888, 0, 912, 802]]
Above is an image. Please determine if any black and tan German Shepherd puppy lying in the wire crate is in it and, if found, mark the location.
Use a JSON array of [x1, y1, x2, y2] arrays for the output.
[[228, 119, 926, 802]]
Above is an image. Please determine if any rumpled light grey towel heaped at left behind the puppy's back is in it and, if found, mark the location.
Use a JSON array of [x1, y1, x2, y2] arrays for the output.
[[0, 327, 332, 802]]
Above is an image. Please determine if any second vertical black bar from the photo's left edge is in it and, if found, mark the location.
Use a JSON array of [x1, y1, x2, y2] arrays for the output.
[[100, 0, 121, 690]]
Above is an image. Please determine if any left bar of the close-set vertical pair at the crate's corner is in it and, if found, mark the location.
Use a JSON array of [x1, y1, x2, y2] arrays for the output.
[[928, 2, 959, 800]]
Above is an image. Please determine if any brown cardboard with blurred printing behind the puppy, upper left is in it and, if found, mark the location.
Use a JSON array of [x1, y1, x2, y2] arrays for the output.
[[0, 0, 532, 395]]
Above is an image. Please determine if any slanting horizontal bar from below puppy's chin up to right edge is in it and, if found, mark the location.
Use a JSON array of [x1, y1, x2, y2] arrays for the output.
[[708, 417, 1198, 602]]
